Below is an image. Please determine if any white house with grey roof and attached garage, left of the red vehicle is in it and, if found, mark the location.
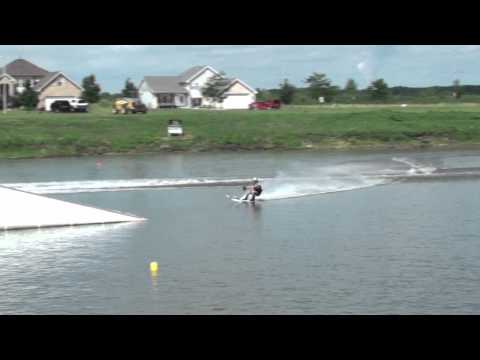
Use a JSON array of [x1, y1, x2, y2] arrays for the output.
[[138, 66, 257, 109]]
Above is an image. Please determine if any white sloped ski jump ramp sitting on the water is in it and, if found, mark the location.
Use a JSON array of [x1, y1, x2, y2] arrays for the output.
[[0, 186, 146, 231]]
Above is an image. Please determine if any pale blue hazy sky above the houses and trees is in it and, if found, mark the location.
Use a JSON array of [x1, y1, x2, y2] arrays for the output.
[[0, 45, 480, 92]]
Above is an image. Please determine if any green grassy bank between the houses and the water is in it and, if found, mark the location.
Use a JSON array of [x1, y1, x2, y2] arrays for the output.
[[0, 104, 480, 158]]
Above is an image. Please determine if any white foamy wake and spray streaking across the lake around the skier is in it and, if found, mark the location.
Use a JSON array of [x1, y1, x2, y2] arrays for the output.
[[3, 158, 436, 200]]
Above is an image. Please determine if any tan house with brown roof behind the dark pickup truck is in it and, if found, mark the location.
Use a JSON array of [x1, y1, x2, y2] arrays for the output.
[[0, 59, 83, 110]]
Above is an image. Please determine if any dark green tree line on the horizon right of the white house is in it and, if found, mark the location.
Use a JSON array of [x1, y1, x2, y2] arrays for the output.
[[257, 72, 470, 104]]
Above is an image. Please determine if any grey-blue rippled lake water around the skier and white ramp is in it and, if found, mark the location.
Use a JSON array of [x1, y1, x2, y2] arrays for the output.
[[0, 150, 480, 314]]
